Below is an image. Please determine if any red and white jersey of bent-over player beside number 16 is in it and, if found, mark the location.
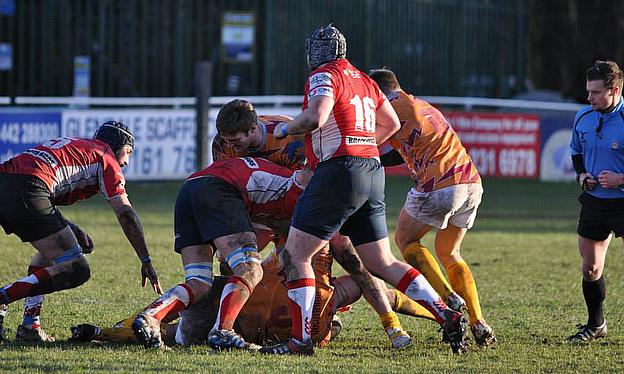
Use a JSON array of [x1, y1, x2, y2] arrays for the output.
[[187, 157, 303, 219]]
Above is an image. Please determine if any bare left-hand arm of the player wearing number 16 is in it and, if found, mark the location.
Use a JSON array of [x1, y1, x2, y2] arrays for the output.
[[273, 96, 332, 139]]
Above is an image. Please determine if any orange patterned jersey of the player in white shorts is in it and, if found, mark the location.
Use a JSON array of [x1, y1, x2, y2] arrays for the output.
[[388, 90, 481, 192]]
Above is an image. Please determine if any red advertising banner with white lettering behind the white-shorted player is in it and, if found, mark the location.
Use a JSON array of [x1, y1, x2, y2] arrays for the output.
[[386, 112, 540, 179]]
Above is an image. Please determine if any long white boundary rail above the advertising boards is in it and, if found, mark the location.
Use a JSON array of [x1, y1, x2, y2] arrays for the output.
[[0, 95, 583, 112]]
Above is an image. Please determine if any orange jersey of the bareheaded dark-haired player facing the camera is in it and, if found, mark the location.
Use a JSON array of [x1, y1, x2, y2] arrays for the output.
[[212, 115, 305, 170]]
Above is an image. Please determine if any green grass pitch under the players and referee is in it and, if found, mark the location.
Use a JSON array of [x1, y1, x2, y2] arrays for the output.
[[0, 177, 624, 373]]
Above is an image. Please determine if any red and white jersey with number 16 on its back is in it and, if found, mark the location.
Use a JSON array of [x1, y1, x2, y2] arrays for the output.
[[302, 58, 386, 169]]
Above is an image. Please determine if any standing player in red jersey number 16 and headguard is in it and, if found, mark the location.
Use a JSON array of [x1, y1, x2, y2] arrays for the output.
[[261, 25, 465, 355]]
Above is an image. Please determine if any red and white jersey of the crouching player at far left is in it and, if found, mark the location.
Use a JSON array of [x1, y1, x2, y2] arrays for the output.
[[0, 138, 126, 205]]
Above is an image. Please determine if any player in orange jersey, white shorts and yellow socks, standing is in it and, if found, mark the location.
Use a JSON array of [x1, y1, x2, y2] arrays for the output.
[[370, 69, 496, 346]]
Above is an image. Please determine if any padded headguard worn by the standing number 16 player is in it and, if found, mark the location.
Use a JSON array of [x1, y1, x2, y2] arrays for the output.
[[306, 24, 347, 70]]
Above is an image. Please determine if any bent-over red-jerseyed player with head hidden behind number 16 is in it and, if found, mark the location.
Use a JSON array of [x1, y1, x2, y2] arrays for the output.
[[132, 157, 310, 349]]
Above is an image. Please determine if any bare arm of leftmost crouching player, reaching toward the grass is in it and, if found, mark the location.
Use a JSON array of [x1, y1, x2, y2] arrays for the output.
[[109, 195, 162, 294]]
